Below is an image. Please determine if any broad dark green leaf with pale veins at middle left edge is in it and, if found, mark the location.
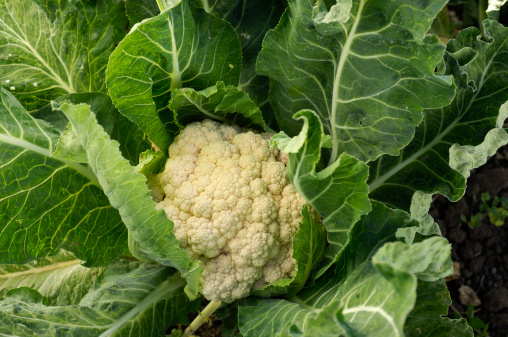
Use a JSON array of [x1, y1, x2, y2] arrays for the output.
[[0, 89, 127, 265]]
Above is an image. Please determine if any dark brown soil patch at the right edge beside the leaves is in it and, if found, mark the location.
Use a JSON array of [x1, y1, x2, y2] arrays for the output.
[[430, 147, 508, 337]]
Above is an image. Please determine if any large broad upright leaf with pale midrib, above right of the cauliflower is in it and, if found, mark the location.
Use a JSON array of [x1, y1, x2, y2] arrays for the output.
[[257, 0, 455, 163]]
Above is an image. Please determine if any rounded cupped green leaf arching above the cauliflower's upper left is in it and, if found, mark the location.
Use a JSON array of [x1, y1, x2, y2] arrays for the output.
[[106, 0, 241, 151]]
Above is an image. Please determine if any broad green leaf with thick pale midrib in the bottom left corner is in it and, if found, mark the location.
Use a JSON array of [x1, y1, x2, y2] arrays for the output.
[[0, 260, 200, 337]]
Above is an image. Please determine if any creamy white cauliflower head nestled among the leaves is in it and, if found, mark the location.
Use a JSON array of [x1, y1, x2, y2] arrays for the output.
[[149, 120, 305, 303]]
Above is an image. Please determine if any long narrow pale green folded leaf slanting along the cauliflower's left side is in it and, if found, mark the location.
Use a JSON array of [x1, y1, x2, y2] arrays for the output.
[[53, 102, 200, 293]]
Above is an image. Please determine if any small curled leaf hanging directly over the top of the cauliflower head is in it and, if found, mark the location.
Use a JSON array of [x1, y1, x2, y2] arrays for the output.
[[169, 82, 265, 136]]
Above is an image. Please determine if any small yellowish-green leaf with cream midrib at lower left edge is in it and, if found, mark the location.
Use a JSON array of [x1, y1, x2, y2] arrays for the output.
[[0, 251, 102, 305]]
